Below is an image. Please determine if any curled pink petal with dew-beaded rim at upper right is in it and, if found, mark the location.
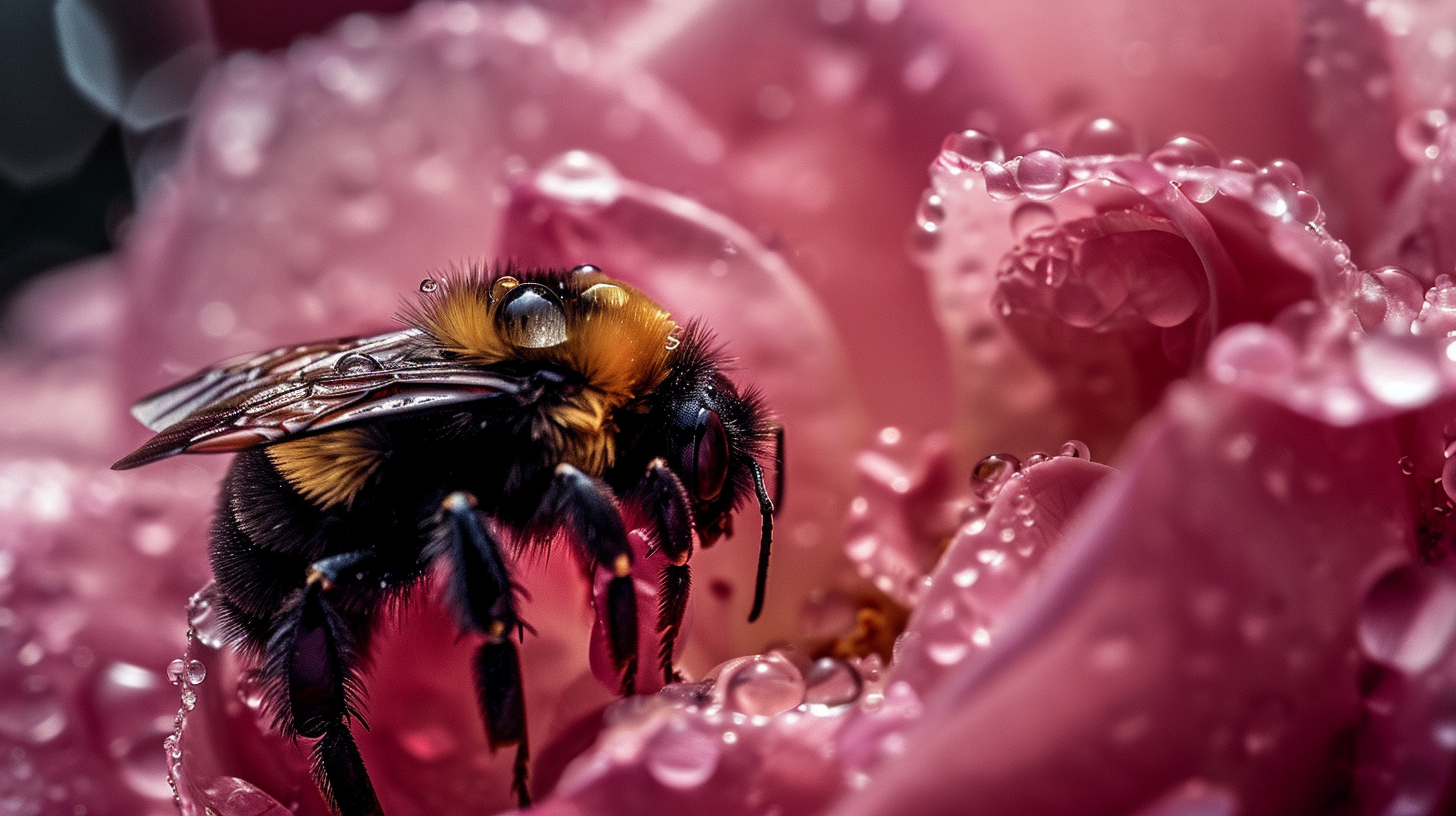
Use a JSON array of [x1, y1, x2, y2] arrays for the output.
[[916, 131, 1327, 456]]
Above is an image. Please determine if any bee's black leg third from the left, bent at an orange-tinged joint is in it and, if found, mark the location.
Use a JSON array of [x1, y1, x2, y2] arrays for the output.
[[533, 463, 638, 695]]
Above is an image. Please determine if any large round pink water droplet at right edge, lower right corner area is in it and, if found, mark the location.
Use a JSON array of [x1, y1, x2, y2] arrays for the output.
[[1358, 564, 1456, 673]]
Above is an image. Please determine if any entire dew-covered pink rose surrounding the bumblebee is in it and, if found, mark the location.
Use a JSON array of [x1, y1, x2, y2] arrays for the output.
[[8, 0, 1456, 816]]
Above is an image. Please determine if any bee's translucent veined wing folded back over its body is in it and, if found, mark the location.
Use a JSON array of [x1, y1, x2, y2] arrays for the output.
[[112, 331, 526, 471]]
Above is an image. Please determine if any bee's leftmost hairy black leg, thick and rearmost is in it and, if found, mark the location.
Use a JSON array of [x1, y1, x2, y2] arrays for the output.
[[264, 581, 381, 816]]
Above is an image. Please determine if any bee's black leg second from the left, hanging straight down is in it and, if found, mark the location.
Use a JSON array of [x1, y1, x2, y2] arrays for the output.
[[434, 493, 531, 809]]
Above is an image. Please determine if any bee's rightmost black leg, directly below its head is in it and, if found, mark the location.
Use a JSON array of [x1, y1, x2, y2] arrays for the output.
[[638, 459, 693, 683]]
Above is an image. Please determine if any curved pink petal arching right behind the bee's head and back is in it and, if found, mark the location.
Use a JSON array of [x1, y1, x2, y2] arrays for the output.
[[498, 163, 862, 655]]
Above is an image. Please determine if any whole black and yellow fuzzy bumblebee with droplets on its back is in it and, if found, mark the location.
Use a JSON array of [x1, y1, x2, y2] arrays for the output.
[[114, 265, 783, 816]]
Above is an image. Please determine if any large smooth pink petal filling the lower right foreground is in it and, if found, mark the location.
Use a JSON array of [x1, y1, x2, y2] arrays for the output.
[[834, 386, 1409, 816]]
